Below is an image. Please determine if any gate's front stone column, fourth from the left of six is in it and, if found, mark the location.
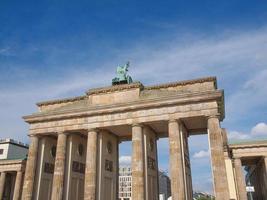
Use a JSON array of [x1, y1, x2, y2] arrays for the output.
[[132, 124, 145, 200]]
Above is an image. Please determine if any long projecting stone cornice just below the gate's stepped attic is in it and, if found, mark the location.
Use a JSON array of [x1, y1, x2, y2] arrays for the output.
[[23, 90, 223, 123]]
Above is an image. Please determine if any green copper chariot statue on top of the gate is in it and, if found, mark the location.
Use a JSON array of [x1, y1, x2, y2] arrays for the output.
[[112, 62, 133, 85]]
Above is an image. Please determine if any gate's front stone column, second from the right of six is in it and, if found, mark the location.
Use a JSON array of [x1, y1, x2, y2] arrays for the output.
[[169, 120, 185, 200]]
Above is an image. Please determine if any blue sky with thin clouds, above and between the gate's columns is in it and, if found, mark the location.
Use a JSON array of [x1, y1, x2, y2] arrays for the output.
[[0, 0, 267, 194]]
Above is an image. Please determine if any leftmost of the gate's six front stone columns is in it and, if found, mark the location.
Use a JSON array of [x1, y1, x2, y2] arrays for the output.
[[21, 136, 39, 200]]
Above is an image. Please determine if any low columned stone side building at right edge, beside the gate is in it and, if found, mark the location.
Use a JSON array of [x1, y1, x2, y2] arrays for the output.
[[228, 139, 267, 199]]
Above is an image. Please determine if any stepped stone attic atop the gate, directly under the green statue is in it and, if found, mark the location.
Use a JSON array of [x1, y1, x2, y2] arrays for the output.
[[34, 77, 217, 112]]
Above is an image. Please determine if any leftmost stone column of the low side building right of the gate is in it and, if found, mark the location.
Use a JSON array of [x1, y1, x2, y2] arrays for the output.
[[234, 158, 247, 200]]
